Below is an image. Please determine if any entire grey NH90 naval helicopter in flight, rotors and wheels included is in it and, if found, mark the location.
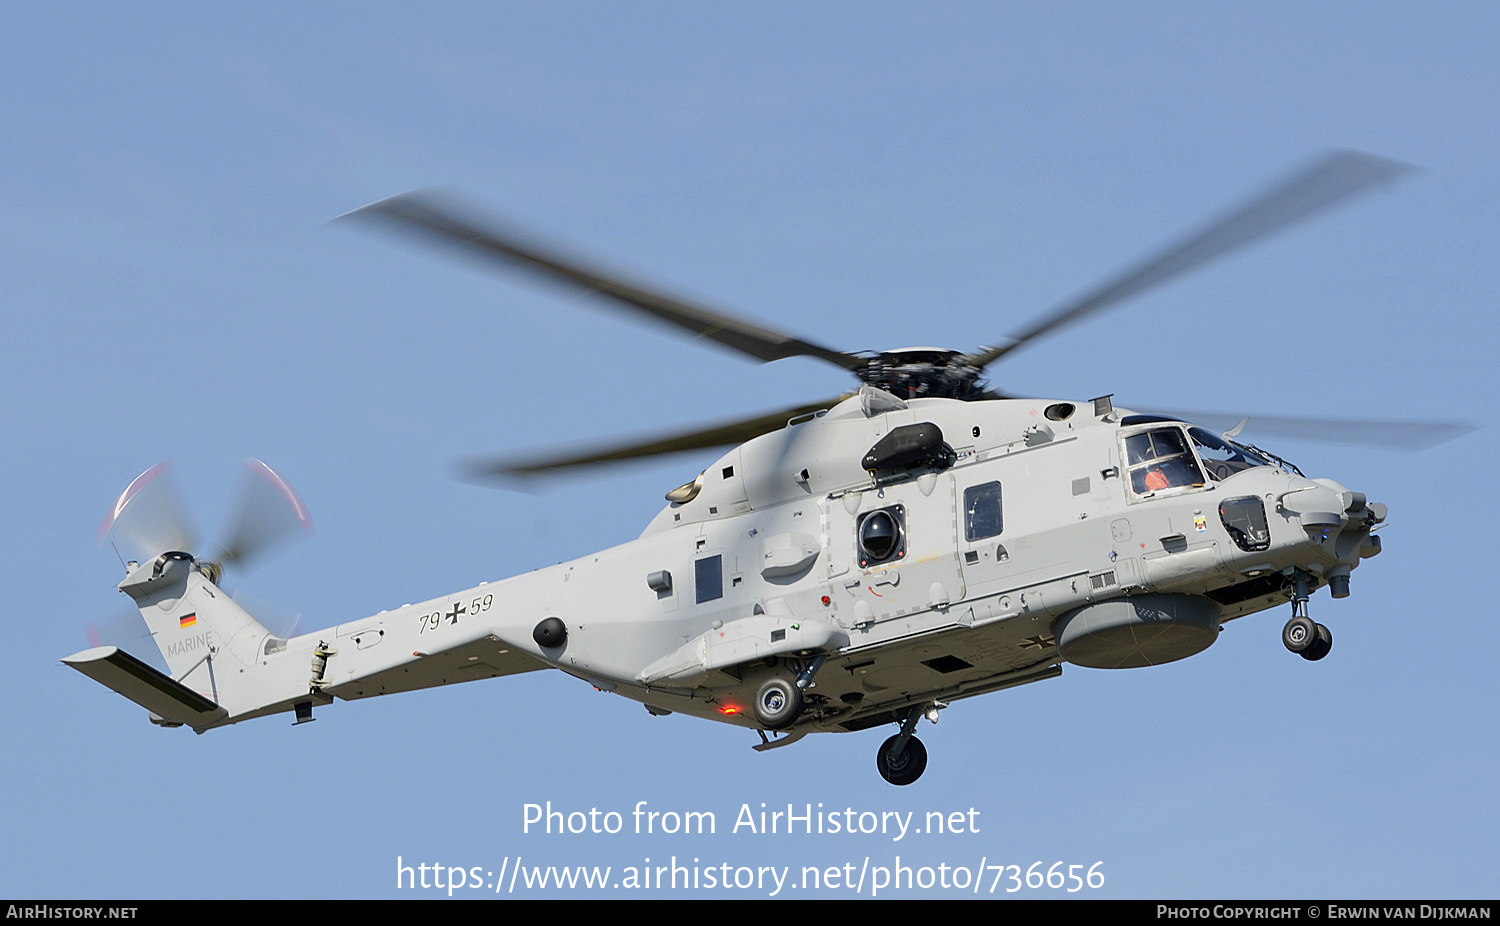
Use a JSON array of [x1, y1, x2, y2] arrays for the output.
[[63, 152, 1464, 785]]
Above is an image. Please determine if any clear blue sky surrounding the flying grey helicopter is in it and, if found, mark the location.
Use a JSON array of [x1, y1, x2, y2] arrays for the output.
[[0, 3, 1500, 897]]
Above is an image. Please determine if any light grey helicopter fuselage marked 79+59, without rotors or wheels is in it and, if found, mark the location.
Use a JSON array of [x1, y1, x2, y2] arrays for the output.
[[90, 387, 1385, 738]]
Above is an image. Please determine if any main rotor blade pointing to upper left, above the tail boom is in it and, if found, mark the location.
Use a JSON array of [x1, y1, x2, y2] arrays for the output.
[[341, 192, 864, 369]]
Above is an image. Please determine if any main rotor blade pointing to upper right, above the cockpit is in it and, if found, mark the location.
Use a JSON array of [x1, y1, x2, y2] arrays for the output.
[[968, 152, 1415, 368]]
